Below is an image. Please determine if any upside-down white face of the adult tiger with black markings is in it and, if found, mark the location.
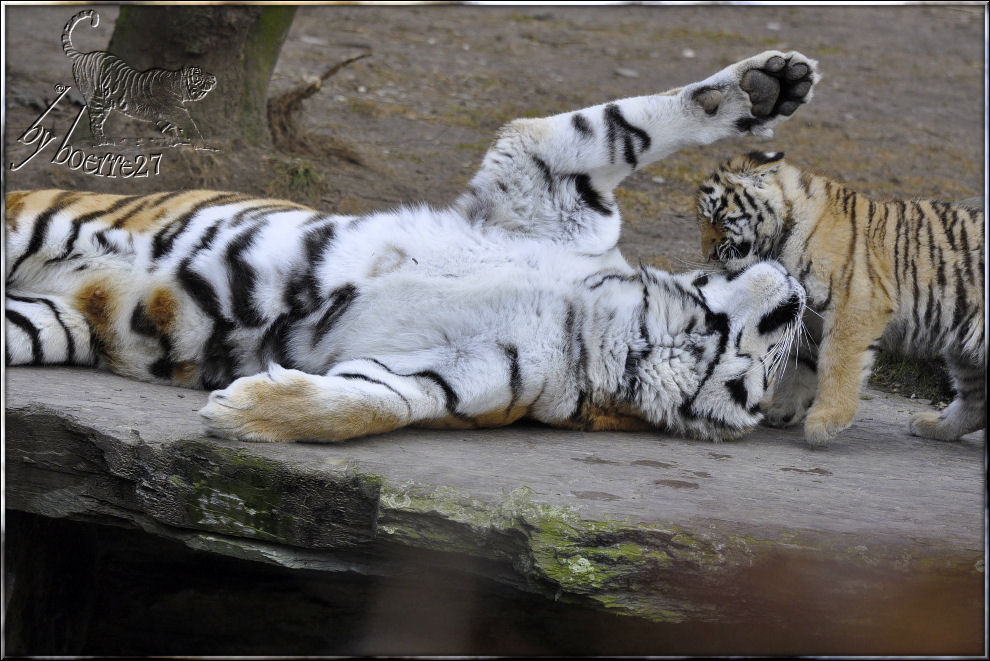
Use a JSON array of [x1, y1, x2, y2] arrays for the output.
[[651, 261, 805, 440]]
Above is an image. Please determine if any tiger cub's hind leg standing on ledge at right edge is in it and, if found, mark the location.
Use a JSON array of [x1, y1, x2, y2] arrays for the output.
[[909, 356, 987, 441]]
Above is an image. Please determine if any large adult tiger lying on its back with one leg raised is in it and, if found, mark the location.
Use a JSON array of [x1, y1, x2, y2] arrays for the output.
[[6, 52, 815, 441]]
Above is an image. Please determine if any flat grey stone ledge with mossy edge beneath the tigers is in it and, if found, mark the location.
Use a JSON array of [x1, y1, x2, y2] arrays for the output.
[[5, 368, 985, 625]]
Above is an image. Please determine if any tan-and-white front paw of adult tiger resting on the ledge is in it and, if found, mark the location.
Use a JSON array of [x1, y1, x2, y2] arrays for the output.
[[199, 367, 311, 443]]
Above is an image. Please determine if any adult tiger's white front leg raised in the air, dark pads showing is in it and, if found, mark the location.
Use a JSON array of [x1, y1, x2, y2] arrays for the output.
[[457, 51, 819, 253]]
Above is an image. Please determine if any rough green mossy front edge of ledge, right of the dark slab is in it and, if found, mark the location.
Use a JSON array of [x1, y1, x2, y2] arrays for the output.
[[378, 484, 722, 622]]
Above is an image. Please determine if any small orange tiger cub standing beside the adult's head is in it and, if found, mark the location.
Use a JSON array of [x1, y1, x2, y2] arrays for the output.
[[697, 152, 986, 446]]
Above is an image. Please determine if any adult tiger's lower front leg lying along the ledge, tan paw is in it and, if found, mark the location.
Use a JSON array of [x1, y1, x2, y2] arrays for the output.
[[199, 350, 538, 442]]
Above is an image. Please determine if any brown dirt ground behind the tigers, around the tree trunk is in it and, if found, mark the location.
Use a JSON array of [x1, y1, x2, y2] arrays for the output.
[[5, 3, 985, 270]]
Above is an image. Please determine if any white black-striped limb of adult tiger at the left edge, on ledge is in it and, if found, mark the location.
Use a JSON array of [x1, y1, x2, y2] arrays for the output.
[[4, 292, 97, 365]]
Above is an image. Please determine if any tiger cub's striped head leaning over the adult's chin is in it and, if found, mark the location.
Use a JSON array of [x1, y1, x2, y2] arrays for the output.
[[696, 152, 784, 273]]
